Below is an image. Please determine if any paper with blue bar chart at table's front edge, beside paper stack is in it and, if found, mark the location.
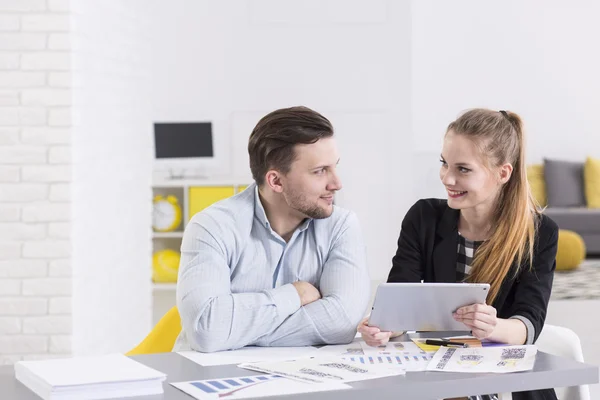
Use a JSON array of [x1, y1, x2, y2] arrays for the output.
[[171, 374, 350, 399]]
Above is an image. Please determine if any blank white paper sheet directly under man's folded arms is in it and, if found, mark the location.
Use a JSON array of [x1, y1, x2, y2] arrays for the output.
[[178, 346, 318, 367]]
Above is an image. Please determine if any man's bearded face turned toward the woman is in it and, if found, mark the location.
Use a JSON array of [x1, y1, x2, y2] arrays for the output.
[[281, 137, 342, 219]]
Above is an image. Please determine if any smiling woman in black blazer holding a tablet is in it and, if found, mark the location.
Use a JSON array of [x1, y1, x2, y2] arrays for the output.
[[358, 109, 558, 400]]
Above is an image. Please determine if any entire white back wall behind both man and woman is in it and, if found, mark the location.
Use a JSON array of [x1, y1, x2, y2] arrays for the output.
[[153, 0, 600, 332]]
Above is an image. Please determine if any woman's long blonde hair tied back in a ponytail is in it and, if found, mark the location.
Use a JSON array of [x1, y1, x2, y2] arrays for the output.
[[447, 108, 539, 304]]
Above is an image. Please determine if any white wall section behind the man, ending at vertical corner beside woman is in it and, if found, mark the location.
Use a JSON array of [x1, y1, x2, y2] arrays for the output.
[[152, 0, 413, 279]]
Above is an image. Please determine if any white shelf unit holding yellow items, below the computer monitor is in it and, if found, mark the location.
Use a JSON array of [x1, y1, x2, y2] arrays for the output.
[[150, 179, 251, 325]]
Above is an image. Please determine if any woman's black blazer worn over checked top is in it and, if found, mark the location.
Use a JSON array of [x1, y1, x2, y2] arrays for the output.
[[388, 199, 558, 400]]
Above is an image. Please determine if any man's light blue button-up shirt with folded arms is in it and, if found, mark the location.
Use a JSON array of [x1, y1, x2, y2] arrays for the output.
[[174, 184, 370, 352]]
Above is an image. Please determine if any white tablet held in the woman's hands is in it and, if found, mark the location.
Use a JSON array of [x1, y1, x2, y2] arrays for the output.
[[369, 283, 490, 332]]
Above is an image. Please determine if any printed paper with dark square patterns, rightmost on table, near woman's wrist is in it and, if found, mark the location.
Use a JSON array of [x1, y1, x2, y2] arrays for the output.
[[427, 345, 537, 373]]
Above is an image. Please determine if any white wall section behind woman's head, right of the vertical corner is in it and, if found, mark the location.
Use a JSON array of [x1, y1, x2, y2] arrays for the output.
[[411, 0, 600, 192]]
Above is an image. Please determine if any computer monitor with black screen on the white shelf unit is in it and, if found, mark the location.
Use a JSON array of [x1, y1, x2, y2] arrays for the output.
[[154, 122, 215, 178]]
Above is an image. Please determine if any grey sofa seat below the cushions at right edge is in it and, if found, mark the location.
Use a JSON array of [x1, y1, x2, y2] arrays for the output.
[[544, 207, 600, 256]]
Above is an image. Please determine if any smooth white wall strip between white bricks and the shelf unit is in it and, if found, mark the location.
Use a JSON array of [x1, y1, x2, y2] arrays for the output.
[[72, 0, 153, 355]]
